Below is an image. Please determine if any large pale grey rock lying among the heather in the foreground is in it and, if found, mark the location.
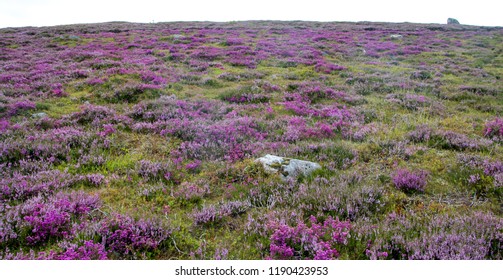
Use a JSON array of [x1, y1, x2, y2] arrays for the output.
[[255, 155, 321, 180]]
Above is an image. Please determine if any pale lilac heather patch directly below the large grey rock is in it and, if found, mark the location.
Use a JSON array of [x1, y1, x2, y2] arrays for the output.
[[248, 174, 386, 221]]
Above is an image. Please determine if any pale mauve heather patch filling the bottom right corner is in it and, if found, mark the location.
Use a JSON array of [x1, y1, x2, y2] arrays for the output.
[[357, 212, 503, 260]]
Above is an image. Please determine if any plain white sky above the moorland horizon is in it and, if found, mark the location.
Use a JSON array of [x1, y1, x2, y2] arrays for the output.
[[0, 0, 503, 28]]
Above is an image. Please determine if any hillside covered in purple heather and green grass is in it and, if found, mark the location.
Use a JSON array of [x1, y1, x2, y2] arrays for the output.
[[0, 21, 503, 259]]
